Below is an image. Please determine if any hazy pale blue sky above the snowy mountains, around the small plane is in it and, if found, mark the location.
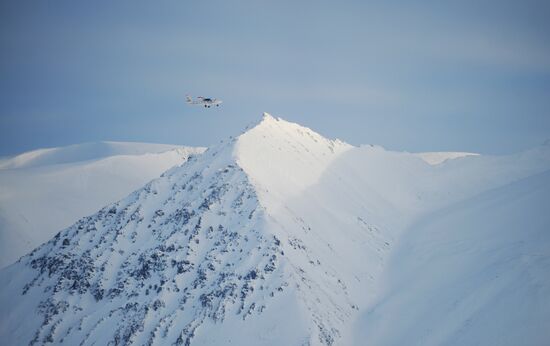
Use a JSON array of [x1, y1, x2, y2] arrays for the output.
[[0, 0, 550, 155]]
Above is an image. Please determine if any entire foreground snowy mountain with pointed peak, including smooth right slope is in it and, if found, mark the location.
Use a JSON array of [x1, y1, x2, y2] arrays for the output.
[[0, 114, 550, 345]]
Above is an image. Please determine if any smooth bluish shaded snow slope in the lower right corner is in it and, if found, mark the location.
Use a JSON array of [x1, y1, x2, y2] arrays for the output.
[[356, 171, 550, 345]]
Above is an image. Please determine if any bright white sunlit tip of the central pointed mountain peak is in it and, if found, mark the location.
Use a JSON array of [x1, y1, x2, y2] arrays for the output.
[[233, 113, 353, 204]]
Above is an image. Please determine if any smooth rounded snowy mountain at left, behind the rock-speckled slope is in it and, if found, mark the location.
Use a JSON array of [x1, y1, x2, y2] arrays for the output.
[[0, 142, 204, 267]]
